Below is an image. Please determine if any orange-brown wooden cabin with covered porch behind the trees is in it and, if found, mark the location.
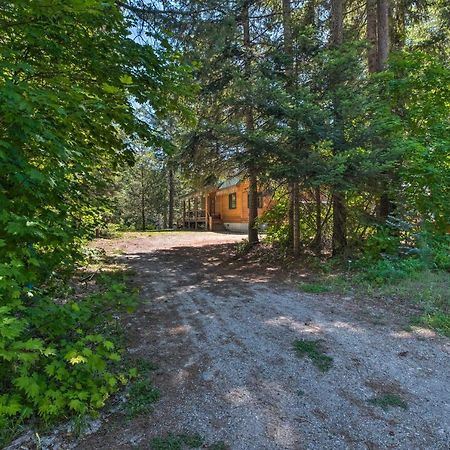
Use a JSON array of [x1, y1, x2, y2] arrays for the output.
[[182, 177, 272, 233]]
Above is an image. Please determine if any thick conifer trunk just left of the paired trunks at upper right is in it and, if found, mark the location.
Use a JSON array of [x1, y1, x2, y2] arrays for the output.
[[330, 0, 347, 255]]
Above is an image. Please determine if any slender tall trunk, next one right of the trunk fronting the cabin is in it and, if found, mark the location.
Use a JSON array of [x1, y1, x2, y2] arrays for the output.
[[282, 0, 300, 256]]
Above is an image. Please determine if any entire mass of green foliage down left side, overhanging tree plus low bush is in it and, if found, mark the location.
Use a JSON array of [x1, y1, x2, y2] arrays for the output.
[[0, 0, 188, 442]]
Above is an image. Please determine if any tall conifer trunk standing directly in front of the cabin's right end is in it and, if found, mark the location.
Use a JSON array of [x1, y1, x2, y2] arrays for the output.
[[242, 1, 259, 245]]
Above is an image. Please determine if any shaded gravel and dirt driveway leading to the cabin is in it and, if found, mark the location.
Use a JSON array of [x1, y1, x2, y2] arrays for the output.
[[78, 232, 450, 450]]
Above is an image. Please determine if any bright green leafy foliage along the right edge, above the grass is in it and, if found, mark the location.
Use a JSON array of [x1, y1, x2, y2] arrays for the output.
[[387, 51, 450, 235]]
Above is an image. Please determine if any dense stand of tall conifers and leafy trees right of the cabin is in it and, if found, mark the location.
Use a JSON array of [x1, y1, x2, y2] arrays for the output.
[[121, 0, 449, 260]]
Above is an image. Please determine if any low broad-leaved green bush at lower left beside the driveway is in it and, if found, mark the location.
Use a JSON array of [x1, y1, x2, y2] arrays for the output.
[[0, 277, 136, 444]]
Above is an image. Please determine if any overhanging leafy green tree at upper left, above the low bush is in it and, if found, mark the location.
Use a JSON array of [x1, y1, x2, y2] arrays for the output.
[[0, 0, 186, 299]]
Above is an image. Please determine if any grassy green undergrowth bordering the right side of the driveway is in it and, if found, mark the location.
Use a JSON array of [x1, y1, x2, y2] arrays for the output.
[[298, 250, 450, 336]]
